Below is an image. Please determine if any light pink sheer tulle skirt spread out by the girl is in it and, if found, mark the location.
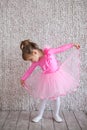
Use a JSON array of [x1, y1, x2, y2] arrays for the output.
[[24, 50, 80, 100]]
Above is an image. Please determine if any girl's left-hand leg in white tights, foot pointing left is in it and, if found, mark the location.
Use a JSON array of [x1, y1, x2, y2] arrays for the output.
[[32, 99, 47, 122]]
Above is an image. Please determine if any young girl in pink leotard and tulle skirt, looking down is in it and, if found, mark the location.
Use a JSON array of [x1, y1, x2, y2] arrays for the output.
[[20, 40, 80, 122]]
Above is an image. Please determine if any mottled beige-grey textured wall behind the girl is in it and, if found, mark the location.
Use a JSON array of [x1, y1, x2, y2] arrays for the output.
[[0, 0, 87, 111]]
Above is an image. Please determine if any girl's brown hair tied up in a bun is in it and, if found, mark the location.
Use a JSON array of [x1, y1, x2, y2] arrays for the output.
[[20, 40, 42, 60]]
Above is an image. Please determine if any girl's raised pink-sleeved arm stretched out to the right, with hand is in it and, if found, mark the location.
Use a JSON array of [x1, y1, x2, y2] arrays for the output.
[[49, 43, 80, 54]]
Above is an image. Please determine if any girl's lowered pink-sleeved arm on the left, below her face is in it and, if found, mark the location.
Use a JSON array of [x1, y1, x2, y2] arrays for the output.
[[21, 62, 37, 81]]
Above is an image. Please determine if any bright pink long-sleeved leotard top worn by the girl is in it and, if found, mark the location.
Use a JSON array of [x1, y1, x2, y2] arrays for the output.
[[21, 43, 73, 80]]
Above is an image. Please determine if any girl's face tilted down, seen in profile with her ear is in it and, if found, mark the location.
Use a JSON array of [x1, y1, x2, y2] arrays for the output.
[[27, 50, 41, 62]]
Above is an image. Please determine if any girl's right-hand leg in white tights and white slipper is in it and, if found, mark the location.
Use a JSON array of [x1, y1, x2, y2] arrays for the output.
[[53, 97, 62, 122]]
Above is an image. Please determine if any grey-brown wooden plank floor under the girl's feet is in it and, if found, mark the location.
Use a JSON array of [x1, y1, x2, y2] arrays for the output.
[[0, 110, 87, 130]]
